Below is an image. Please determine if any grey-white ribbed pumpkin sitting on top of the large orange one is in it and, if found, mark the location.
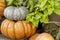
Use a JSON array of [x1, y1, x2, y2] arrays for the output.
[[4, 6, 28, 20]]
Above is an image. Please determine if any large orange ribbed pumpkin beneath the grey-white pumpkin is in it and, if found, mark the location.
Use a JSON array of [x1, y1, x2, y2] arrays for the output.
[[1, 19, 36, 39]]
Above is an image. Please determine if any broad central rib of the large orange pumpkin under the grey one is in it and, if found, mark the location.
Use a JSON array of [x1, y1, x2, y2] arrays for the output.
[[15, 21, 24, 39]]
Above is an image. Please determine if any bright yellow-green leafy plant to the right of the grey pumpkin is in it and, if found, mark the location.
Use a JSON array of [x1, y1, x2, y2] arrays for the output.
[[26, 0, 60, 27]]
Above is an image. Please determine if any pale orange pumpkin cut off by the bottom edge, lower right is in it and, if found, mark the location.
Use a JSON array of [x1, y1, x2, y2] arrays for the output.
[[29, 33, 54, 40]]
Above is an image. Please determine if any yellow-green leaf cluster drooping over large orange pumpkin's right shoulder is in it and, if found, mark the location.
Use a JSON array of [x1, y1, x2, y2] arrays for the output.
[[26, 12, 42, 27]]
